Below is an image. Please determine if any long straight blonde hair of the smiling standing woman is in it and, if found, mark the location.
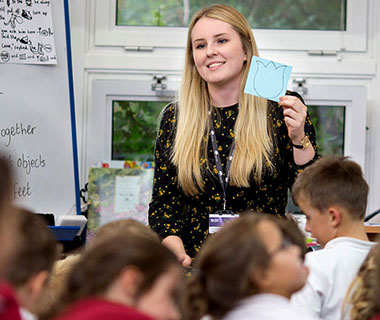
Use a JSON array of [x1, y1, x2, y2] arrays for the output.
[[172, 5, 273, 196]]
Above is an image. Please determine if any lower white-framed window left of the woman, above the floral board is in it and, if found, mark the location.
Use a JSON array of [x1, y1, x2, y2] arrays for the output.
[[85, 80, 179, 170]]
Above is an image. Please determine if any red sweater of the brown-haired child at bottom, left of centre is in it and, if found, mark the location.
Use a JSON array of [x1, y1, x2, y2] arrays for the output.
[[55, 298, 153, 320]]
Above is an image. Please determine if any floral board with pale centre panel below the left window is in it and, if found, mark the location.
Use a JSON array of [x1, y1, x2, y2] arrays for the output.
[[87, 161, 154, 241]]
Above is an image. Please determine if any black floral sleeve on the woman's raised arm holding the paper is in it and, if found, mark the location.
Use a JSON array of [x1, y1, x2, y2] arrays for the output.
[[273, 91, 319, 188]]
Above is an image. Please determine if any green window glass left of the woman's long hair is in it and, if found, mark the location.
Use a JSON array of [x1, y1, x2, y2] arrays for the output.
[[112, 101, 167, 161]]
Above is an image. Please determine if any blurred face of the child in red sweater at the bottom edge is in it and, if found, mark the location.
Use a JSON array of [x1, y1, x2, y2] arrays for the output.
[[135, 266, 182, 320]]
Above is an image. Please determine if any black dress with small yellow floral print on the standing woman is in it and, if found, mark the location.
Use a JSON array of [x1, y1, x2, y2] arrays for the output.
[[149, 92, 317, 257]]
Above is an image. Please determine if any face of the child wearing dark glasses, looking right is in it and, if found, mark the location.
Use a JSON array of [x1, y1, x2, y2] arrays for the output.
[[258, 220, 308, 298]]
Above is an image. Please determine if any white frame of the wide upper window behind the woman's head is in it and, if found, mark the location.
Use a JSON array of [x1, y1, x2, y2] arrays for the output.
[[92, 0, 368, 53]]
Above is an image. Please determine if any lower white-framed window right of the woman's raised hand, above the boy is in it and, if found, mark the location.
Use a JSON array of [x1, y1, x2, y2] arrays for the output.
[[303, 85, 367, 171]]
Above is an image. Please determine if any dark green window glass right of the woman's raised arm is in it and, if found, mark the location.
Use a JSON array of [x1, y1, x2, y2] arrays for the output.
[[308, 106, 345, 156]]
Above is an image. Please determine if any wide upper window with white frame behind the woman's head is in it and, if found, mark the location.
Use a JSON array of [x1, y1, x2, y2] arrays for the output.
[[90, 0, 368, 52]]
